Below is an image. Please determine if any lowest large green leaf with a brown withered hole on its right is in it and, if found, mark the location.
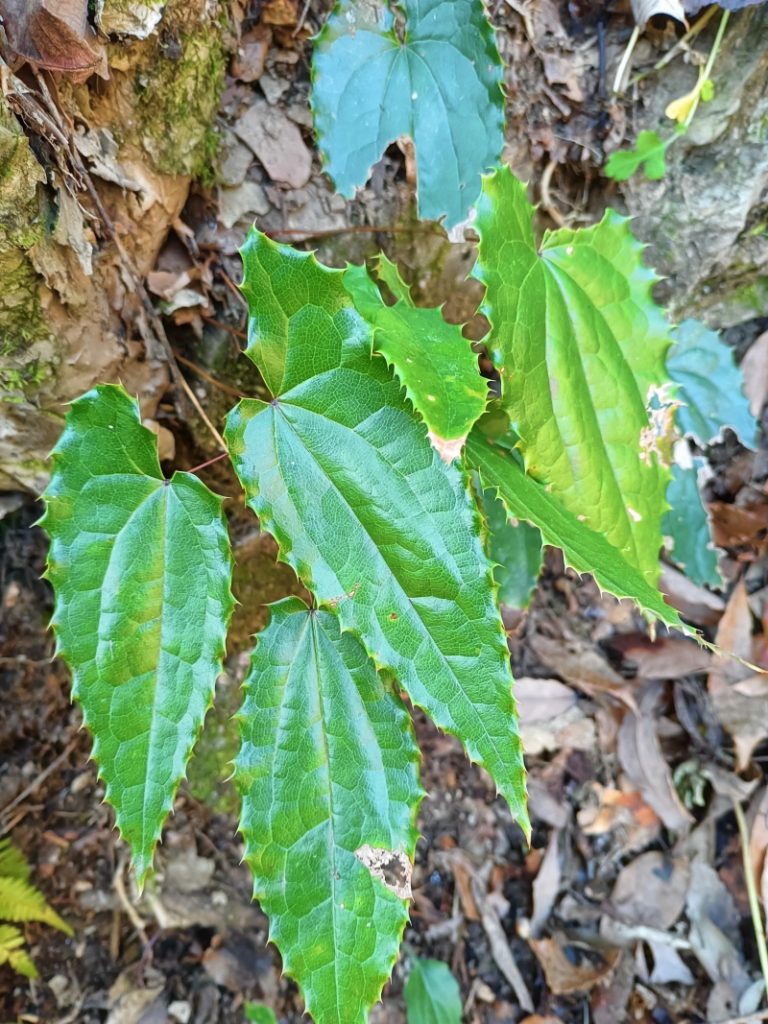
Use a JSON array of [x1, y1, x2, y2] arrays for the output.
[[234, 598, 423, 1024]]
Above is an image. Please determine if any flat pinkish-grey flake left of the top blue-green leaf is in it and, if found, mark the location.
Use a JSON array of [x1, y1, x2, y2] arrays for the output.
[[234, 99, 312, 188]]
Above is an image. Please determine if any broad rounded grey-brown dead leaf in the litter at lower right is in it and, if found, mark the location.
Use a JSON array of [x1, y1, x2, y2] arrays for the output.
[[610, 851, 690, 931]]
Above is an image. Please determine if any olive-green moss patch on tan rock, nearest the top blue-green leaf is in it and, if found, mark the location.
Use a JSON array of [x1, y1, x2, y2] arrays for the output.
[[136, 20, 226, 182]]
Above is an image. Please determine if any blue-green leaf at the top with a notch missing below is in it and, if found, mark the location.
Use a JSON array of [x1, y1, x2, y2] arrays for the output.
[[311, 0, 505, 225]]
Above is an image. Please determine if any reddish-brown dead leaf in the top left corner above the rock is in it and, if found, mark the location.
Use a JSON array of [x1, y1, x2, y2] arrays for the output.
[[0, 0, 110, 82]]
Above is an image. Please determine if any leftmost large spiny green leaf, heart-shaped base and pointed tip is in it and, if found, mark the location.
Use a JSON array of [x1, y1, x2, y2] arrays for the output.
[[42, 385, 233, 884]]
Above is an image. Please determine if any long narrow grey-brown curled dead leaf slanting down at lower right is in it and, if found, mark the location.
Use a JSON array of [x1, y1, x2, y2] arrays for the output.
[[618, 684, 693, 831]]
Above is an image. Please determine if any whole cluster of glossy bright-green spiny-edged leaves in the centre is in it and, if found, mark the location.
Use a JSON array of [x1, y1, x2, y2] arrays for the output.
[[42, 168, 696, 1024]]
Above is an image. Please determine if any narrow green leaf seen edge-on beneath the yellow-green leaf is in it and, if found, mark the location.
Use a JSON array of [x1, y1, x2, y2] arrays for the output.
[[466, 419, 685, 631]]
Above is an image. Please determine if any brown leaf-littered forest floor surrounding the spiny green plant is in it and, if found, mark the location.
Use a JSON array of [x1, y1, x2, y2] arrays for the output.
[[0, 0, 768, 1024]]
